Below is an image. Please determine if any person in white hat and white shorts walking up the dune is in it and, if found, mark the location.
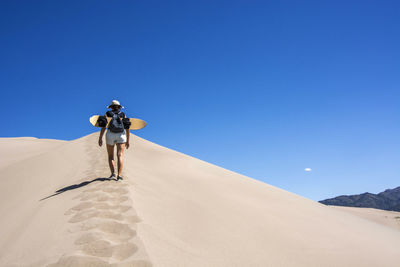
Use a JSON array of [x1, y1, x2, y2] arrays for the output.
[[99, 100, 130, 180]]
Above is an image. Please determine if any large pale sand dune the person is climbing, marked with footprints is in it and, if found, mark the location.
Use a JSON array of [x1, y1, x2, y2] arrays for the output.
[[0, 133, 400, 266]]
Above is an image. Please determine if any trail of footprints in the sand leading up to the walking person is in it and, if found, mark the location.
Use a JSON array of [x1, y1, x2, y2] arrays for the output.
[[48, 135, 152, 267]]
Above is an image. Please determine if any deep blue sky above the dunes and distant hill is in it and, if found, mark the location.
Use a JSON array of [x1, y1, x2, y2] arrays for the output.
[[0, 0, 400, 200]]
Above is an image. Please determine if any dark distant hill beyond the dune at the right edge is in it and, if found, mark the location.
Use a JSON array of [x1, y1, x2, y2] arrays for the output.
[[319, 186, 400, 211]]
